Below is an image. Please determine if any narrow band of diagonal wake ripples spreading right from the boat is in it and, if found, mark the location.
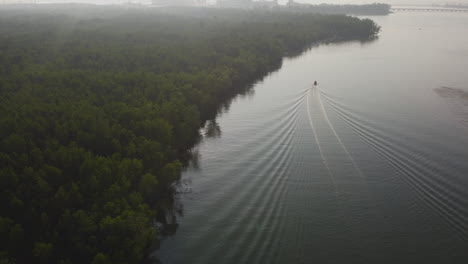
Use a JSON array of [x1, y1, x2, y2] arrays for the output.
[[323, 94, 468, 241]]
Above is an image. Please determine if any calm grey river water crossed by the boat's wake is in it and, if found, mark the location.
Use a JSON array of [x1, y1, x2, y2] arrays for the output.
[[155, 12, 468, 263]]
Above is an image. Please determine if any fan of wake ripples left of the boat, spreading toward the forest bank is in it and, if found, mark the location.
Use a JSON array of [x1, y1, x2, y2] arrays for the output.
[[185, 86, 308, 263]]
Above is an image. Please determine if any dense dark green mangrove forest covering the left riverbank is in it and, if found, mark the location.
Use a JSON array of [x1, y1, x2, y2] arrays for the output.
[[0, 7, 379, 264]]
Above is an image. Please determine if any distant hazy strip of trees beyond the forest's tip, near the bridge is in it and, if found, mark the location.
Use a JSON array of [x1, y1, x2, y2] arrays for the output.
[[287, 3, 391, 16]]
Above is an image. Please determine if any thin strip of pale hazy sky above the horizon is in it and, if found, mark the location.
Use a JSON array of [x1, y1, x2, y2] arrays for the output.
[[0, 0, 468, 4]]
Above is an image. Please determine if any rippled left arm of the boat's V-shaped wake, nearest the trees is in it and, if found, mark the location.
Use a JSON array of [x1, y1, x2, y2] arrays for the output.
[[189, 87, 304, 263]]
